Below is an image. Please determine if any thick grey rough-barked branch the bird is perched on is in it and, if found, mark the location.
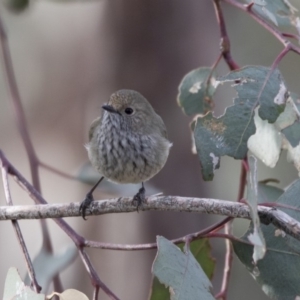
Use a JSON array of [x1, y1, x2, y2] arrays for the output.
[[0, 195, 300, 240]]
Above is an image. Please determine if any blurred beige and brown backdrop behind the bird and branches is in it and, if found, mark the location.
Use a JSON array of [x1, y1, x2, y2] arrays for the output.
[[0, 0, 300, 300]]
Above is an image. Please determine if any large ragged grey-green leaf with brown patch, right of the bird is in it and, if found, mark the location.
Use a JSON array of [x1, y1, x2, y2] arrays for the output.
[[194, 66, 287, 180]]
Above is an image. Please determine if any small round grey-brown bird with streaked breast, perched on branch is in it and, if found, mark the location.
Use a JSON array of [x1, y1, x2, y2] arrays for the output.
[[79, 90, 172, 219]]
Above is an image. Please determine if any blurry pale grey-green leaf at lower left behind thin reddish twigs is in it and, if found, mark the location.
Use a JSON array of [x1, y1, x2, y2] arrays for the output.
[[24, 246, 77, 291]]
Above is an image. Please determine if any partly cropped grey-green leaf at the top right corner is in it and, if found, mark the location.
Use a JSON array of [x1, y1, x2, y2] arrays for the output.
[[241, 0, 297, 26]]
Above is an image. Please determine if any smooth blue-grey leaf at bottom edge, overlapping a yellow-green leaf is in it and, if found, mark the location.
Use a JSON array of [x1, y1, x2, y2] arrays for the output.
[[152, 236, 214, 300]]
